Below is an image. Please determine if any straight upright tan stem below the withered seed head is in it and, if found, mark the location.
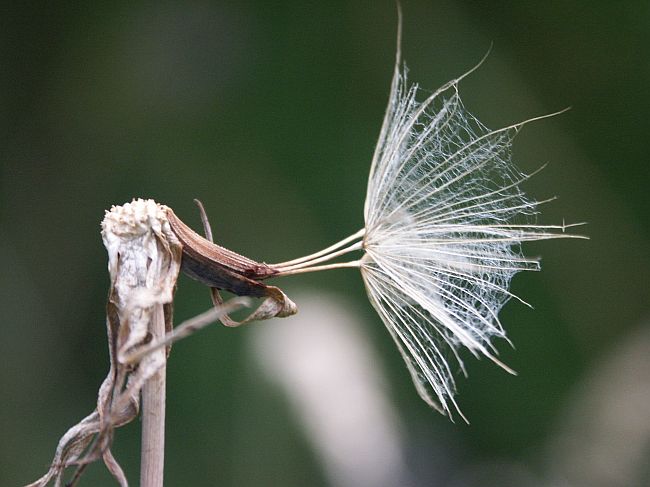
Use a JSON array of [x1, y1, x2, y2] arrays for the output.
[[140, 305, 167, 487]]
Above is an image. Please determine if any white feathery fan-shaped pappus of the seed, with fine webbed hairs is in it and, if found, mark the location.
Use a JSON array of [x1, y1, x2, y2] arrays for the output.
[[361, 24, 570, 416]]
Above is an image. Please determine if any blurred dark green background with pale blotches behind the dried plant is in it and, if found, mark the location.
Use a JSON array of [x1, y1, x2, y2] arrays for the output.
[[0, 0, 650, 487]]
